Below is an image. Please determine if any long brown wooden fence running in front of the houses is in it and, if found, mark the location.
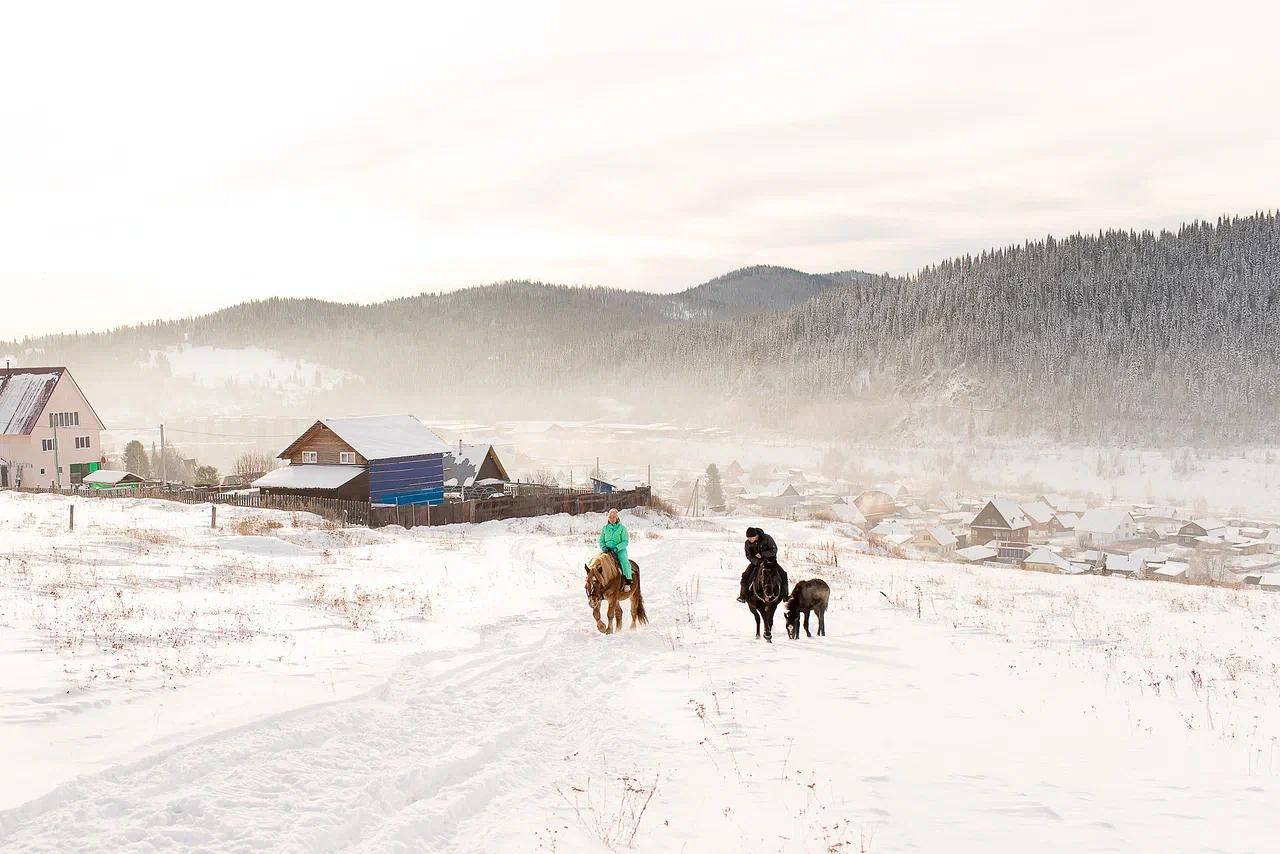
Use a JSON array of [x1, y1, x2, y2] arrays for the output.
[[5, 487, 652, 528]]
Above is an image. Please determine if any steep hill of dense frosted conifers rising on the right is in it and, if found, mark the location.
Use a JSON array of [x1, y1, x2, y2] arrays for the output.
[[558, 214, 1280, 444]]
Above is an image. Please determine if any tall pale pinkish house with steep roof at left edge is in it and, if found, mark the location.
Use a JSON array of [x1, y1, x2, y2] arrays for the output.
[[0, 367, 104, 487]]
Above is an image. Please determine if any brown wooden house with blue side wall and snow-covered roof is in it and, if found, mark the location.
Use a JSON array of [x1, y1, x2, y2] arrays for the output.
[[253, 415, 449, 504]]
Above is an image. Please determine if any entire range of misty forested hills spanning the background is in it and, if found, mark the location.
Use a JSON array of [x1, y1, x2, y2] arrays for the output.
[[0, 214, 1280, 446]]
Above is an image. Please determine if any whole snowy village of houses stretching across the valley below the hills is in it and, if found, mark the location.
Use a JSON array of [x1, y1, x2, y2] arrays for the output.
[[0, 366, 1280, 590]]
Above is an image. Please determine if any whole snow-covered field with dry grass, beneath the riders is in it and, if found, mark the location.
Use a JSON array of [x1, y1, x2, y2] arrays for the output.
[[0, 493, 1280, 853]]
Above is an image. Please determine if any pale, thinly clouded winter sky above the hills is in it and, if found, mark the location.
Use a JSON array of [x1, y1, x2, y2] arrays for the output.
[[0, 0, 1280, 339]]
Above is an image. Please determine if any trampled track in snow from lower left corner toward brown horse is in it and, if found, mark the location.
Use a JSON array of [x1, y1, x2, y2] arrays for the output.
[[0, 594, 650, 851]]
